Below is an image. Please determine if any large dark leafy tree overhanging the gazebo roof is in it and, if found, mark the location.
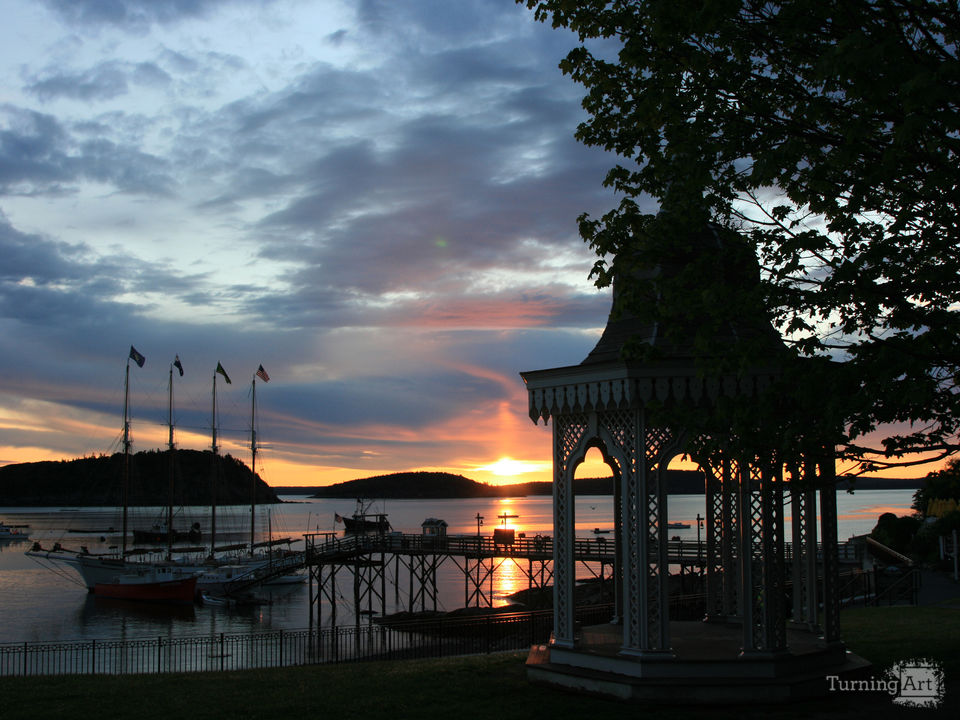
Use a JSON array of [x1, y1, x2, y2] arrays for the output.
[[517, 0, 960, 471]]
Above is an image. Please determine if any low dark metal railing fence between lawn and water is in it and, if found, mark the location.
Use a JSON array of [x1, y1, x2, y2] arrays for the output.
[[0, 605, 611, 677]]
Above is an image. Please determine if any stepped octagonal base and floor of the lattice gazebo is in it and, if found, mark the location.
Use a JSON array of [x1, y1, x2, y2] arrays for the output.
[[527, 622, 871, 705]]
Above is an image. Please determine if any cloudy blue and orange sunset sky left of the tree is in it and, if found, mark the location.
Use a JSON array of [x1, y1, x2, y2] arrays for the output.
[[0, 0, 632, 485]]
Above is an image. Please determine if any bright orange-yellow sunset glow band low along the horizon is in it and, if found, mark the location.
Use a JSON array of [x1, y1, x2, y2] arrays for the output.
[[0, 388, 945, 496]]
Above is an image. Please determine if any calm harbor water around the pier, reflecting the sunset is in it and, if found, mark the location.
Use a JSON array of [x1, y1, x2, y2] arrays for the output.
[[0, 490, 913, 643]]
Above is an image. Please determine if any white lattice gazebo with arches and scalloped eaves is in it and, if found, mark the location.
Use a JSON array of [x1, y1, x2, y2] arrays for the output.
[[521, 228, 863, 702]]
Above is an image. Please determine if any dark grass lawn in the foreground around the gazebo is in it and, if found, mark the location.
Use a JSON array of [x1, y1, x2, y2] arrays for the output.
[[0, 607, 960, 720]]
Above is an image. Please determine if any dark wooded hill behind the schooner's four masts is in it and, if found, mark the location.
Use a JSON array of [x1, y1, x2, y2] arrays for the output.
[[0, 450, 280, 507]]
